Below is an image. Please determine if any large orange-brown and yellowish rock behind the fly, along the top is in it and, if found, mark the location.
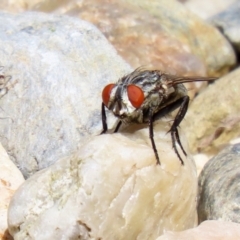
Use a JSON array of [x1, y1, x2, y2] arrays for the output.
[[0, 0, 236, 77]]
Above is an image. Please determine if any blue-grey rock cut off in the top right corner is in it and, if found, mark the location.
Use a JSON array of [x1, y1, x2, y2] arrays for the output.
[[211, 1, 240, 53]]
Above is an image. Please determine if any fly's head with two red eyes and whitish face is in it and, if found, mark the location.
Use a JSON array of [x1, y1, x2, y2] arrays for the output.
[[102, 83, 145, 122]]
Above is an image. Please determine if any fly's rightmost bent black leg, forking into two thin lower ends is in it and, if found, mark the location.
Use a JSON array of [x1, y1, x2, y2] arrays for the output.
[[169, 96, 189, 165]]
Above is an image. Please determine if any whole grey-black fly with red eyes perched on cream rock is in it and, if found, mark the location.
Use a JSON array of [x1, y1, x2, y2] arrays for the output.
[[101, 68, 217, 165]]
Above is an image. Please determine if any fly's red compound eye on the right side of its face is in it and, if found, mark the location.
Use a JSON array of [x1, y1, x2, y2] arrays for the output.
[[127, 85, 144, 108]]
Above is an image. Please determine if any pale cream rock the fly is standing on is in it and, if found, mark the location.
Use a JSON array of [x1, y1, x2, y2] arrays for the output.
[[8, 122, 197, 240]]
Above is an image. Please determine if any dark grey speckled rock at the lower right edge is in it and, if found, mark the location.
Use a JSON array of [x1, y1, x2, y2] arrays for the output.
[[198, 144, 240, 223]]
